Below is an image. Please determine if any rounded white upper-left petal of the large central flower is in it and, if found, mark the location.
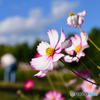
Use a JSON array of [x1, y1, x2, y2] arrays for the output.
[[37, 41, 50, 55]]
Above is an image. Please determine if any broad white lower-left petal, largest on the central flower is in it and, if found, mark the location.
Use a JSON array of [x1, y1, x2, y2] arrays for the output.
[[30, 56, 54, 71]]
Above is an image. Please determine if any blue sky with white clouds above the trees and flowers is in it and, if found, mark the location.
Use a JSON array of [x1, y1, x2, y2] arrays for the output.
[[0, 0, 100, 45]]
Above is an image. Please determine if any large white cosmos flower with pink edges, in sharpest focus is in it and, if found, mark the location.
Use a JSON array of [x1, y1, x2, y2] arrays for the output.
[[30, 29, 72, 77]]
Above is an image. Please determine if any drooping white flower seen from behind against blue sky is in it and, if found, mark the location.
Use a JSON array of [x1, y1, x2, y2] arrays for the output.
[[67, 10, 86, 27]]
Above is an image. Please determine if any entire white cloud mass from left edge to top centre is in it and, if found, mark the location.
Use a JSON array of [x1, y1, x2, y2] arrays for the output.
[[0, 1, 77, 44]]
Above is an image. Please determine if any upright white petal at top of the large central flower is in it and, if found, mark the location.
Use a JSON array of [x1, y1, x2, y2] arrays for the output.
[[47, 29, 59, 48]]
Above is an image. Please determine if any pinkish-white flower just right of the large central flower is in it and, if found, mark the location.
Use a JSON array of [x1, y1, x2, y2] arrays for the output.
[[64, 32, 89, 62]]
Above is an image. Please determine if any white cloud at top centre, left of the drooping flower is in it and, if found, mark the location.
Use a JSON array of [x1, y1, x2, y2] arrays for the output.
[[52, 1, 77, 19]]
